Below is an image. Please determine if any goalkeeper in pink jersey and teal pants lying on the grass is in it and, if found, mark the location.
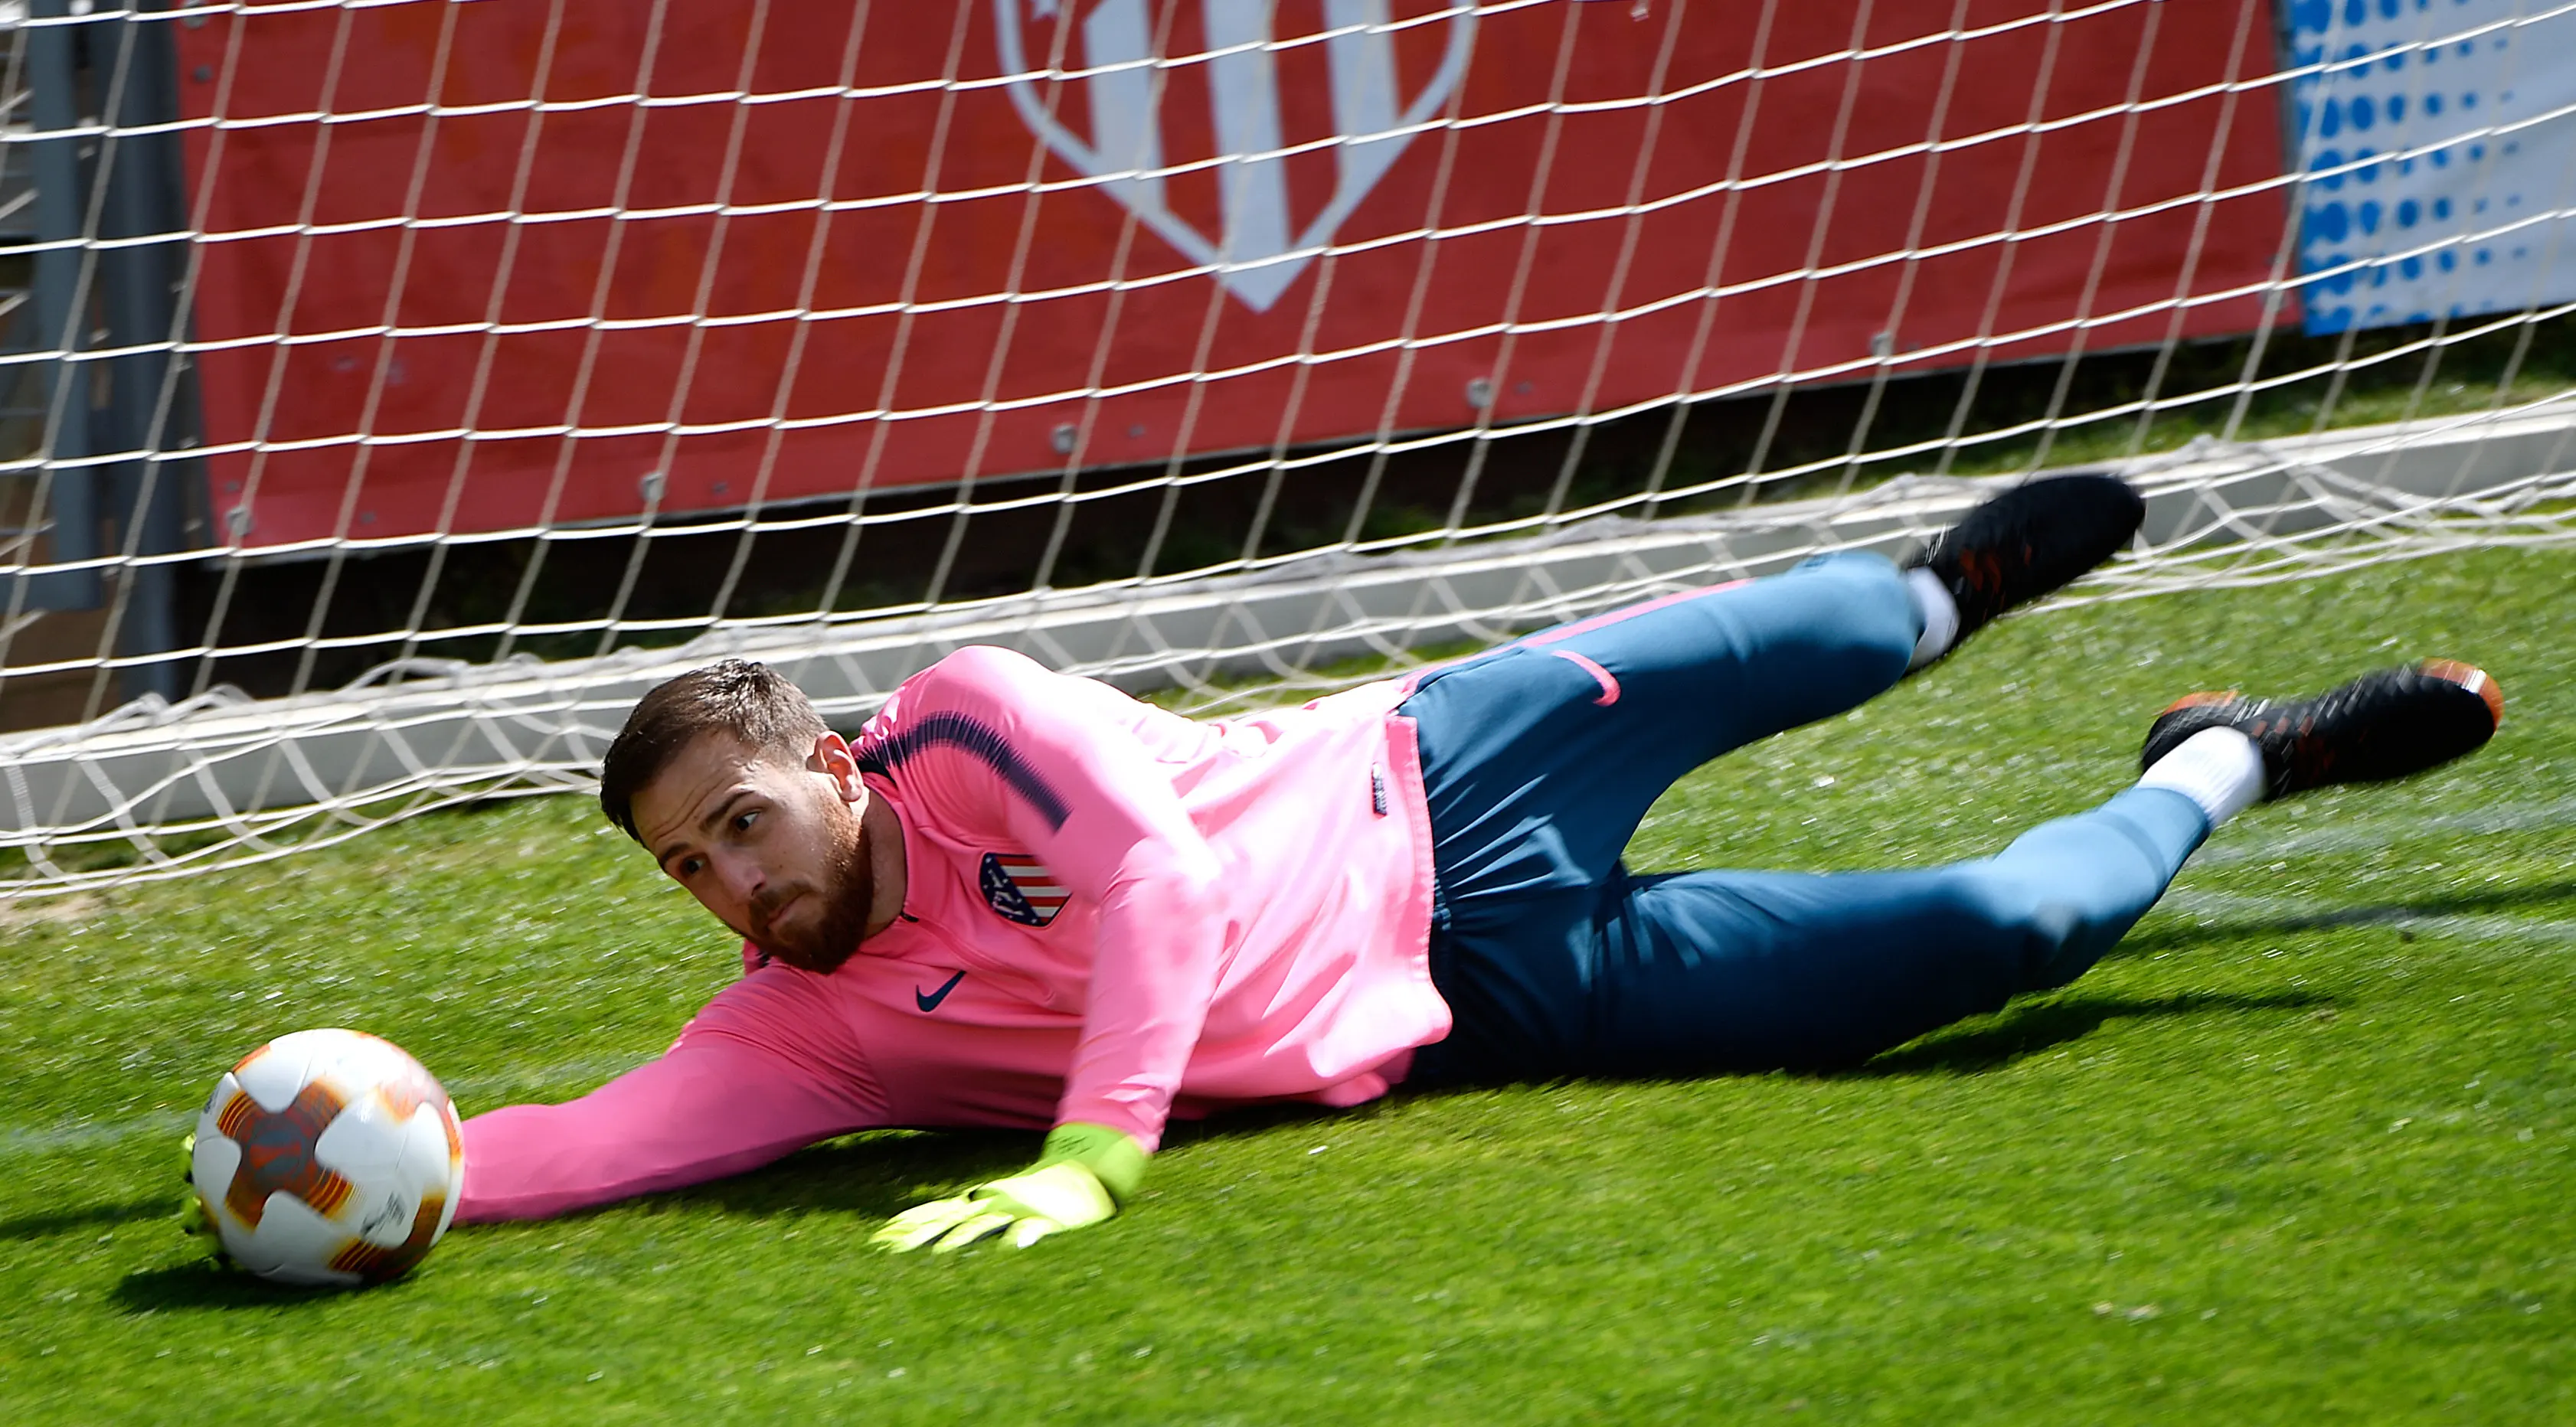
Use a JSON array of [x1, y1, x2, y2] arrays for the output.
[[459, 474, 2504, 1249]]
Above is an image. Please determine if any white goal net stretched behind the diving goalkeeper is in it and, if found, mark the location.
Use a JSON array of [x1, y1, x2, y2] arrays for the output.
[[0, 0, 2576, 899]]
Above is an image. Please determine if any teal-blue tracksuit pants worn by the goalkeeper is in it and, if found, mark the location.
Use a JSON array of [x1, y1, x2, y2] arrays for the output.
[[1404, 553, 2208, 1082]]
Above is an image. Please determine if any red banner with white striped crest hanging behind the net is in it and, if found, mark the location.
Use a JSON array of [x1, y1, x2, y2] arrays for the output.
[[180, 0, 2285, 546]]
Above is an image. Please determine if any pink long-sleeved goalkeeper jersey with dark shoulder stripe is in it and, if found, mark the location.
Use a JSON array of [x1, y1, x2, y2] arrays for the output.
[[459, 647, 1450, 1218]]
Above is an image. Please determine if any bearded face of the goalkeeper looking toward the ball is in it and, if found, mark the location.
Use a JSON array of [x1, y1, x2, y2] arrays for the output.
[[634, 732, 876, 971]]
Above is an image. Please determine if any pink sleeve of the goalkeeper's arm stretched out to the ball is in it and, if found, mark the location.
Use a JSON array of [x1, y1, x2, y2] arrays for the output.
[[456, 966, 884, 1223]]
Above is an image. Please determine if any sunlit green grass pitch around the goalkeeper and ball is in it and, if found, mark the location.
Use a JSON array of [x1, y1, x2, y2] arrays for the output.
[[0, 540, 2576, 1427]]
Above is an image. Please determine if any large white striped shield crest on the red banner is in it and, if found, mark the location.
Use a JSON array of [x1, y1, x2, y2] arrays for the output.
[[995, 0, 1476, 312]]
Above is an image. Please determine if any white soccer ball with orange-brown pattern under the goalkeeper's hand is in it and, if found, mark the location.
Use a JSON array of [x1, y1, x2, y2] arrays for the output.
[[188, 1030, 466, 1288]]
